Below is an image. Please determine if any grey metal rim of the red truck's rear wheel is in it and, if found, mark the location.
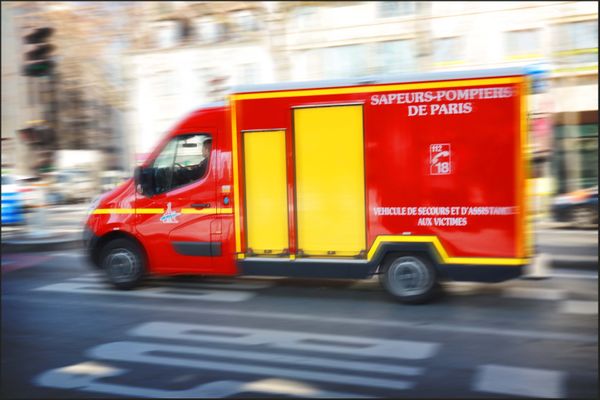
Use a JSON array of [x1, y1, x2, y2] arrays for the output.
[[387, 257, 433, 296]]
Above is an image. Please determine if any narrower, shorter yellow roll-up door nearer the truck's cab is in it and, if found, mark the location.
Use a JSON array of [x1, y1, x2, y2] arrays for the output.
[[244, 131, 288, 255]]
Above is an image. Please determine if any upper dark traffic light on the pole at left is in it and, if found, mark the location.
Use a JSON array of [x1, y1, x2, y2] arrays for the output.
[[23, 27, 55, 76]]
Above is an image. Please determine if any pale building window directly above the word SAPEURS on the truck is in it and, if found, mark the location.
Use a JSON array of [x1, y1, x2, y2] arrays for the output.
[[376, 40, 416, 74]]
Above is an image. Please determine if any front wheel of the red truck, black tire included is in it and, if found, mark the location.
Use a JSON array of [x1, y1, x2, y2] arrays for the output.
[[100, 239, 146, 290]]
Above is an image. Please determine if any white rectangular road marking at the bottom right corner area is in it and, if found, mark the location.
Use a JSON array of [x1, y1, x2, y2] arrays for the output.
[[473, 364, 566, 398]]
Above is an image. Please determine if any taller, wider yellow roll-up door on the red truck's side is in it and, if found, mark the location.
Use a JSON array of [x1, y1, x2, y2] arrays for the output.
[[294, 105, 366, 257]]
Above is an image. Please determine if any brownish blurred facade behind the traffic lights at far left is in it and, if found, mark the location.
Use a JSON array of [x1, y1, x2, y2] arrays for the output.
[[2, 2, 131, 175]]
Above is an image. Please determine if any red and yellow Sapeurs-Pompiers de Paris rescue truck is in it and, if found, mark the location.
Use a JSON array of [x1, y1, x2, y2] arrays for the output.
[[85, 68, 532, 303]]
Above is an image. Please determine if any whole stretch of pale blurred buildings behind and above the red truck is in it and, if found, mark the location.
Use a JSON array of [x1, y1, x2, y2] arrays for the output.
[[128, 1, 598, 203]]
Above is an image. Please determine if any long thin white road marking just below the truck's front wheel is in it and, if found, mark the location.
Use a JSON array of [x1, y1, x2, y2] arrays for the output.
[[33, 282, 256, 302]]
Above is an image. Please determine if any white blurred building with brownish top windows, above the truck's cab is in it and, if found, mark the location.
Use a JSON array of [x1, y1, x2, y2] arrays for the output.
[[127, 2, 275, 160]]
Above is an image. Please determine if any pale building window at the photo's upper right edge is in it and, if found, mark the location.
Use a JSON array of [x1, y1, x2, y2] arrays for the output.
[[554, 20, 598, 64]]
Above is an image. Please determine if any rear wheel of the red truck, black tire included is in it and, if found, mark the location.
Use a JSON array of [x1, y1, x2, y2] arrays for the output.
[[379, 254, 440, 304]]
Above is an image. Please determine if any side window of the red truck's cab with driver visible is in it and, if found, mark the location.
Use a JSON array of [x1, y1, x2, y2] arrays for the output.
[[152, 133, 212, 194]]
